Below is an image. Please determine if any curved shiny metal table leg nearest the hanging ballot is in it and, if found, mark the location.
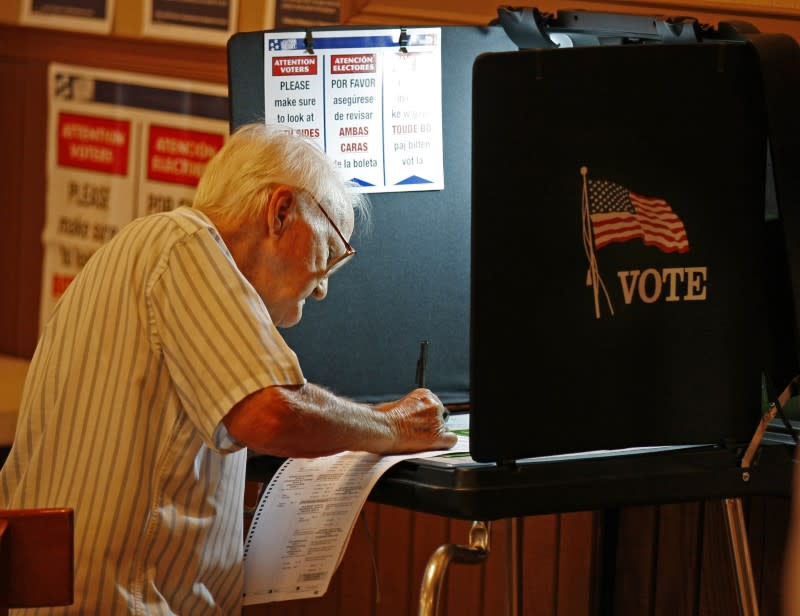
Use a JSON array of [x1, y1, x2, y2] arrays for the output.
[[419, 522, 491, 616]]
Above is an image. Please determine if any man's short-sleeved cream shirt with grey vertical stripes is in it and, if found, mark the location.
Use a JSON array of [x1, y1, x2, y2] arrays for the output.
[[0, 208, 304, 616]]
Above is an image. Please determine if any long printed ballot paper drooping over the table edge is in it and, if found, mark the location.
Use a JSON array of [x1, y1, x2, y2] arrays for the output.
[[244, 435, 469, 605]]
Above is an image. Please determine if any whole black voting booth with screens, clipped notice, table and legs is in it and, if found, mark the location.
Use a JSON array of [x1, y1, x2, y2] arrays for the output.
[[228, 8, 800, 614]]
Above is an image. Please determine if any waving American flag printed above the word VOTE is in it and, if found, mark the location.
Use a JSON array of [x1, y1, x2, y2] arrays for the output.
[[589, 180, 689, 253]]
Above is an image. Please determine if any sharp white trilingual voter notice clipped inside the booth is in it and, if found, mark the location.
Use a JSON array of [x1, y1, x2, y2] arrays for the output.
[[264, 28, 444, 192]]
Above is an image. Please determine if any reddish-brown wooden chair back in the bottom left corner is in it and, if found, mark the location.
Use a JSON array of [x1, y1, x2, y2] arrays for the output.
[[0, 509, 74, 616]]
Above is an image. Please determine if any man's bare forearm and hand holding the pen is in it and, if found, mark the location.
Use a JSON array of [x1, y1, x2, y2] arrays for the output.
[[223, 383, 457, 458]]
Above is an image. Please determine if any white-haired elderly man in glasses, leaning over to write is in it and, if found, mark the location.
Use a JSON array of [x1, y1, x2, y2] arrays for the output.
[[0, 124, 456, 616]]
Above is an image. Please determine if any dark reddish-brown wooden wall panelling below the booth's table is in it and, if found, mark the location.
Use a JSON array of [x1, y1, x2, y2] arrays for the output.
[[238, 497, 788, 616]]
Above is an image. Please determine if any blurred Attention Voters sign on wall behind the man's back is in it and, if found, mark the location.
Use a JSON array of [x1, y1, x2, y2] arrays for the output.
[[40, 63, 229, 327]]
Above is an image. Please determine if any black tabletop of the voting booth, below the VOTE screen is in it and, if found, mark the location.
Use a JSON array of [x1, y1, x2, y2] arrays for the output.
[[247, 427, 794, 521]]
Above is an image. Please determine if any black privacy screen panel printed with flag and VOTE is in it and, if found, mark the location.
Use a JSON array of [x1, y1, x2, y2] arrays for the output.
[[470, 43, 768, 461]]
